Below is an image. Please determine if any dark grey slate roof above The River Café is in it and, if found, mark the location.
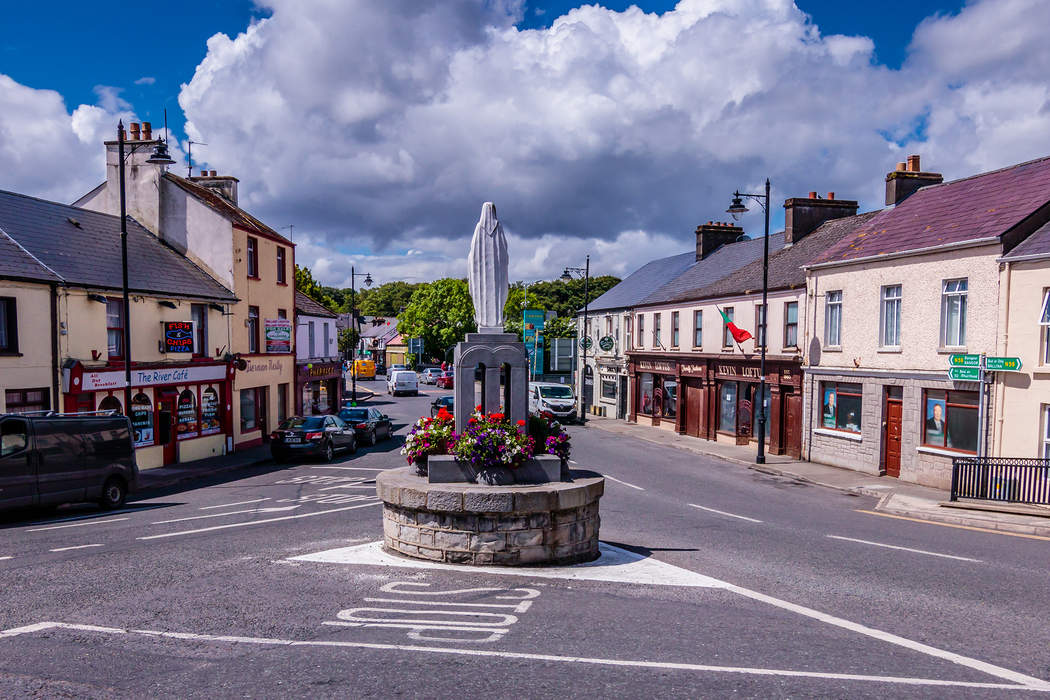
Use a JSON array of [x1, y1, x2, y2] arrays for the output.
[[0, 191, 236, 301]]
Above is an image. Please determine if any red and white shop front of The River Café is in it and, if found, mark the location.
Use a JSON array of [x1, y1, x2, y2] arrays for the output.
[[62, 362, 233, 469]]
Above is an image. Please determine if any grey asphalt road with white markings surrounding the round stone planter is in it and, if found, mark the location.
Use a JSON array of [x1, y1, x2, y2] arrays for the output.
[[0, 382, 1050, 698]]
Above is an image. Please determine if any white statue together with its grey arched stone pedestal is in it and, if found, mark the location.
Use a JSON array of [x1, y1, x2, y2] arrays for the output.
[[455, 201, 528, 432]]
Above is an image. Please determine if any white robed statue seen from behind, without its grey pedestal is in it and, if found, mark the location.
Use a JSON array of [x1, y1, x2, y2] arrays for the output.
[[466, 201, 510, 333]]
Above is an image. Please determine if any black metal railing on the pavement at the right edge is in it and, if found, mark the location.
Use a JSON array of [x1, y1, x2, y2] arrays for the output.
[[951, 457, 1050, 506]]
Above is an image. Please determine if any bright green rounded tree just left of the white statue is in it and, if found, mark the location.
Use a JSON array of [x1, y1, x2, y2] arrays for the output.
[[397, 278, 477, 357]]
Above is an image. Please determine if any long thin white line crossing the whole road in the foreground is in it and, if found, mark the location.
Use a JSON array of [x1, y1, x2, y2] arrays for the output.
[[0, 622, 1050, 693]]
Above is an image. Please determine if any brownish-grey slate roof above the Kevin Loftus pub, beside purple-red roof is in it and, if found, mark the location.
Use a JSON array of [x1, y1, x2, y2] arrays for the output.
[[673, 210, 881, 301]]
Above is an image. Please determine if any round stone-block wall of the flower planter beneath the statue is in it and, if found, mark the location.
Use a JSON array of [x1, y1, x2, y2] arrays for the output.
[[376, 467, 605, 566]]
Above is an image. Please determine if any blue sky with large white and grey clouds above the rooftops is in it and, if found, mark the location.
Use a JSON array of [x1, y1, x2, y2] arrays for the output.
[[0, 0, 1050, 285]]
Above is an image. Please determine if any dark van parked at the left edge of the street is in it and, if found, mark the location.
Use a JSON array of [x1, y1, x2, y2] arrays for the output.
[[0, 413, 139, 509]]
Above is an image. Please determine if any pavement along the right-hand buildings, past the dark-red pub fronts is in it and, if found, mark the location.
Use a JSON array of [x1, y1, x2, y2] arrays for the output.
[[587, 416, 1050, 537]]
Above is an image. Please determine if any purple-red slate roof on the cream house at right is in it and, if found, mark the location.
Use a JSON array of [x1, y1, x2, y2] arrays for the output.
[[814, 156, 1050, 263]]
